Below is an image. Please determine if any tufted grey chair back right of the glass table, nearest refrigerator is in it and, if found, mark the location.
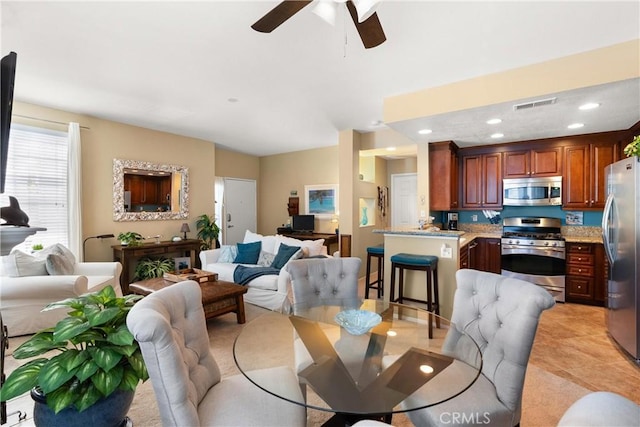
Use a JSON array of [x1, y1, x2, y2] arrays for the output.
[[443, 269, 555, 421]]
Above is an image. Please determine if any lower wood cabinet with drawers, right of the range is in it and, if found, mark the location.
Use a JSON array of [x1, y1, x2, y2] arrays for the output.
[[566, 242, 607, 306]]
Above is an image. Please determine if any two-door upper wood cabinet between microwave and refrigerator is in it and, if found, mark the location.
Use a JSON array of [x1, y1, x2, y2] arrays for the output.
[[562, 139, 620, 210]]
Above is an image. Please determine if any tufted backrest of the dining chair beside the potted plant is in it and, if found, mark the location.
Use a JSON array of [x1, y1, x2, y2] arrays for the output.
[[127, 280, 220, 426]]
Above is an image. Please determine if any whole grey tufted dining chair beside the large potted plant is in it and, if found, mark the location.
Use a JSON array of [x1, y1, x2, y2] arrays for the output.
[[127, 280, 306, 427]]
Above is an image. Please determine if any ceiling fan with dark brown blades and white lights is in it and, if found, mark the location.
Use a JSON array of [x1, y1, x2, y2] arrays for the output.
[[251, 0, 387, 49]]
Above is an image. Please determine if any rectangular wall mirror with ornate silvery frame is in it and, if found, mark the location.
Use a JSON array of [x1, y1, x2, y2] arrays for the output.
[[113, 159, 189, 221]]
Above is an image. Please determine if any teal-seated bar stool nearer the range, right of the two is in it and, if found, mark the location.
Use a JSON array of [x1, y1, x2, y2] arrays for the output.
[[390, 253, 440, 338]]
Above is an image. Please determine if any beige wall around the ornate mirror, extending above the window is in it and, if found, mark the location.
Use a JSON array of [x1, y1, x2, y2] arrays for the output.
[[12, 102, 215, 261]]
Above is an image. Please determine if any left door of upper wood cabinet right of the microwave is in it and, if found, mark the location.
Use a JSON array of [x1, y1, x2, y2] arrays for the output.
[[562, 145, 590, 209]]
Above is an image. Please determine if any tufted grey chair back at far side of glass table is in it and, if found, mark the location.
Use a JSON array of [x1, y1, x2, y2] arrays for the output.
[[287, 257, 361, 307]]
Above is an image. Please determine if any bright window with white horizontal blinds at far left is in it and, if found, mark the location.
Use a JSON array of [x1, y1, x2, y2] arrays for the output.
[[2, 124, 69, 250]]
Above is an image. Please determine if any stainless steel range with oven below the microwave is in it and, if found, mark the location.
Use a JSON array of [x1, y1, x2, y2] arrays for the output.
[[501, 217, 566, 302]]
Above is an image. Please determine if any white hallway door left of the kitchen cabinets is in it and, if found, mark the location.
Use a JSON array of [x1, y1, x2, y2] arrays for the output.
[[391, 173, 418, 227]]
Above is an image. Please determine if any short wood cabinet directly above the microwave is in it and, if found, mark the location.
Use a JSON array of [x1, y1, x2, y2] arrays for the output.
[[503, 146, 562, 178]]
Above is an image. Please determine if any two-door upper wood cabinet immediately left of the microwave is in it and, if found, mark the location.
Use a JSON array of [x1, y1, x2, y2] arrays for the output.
[[462, 153, 502, 209]]
